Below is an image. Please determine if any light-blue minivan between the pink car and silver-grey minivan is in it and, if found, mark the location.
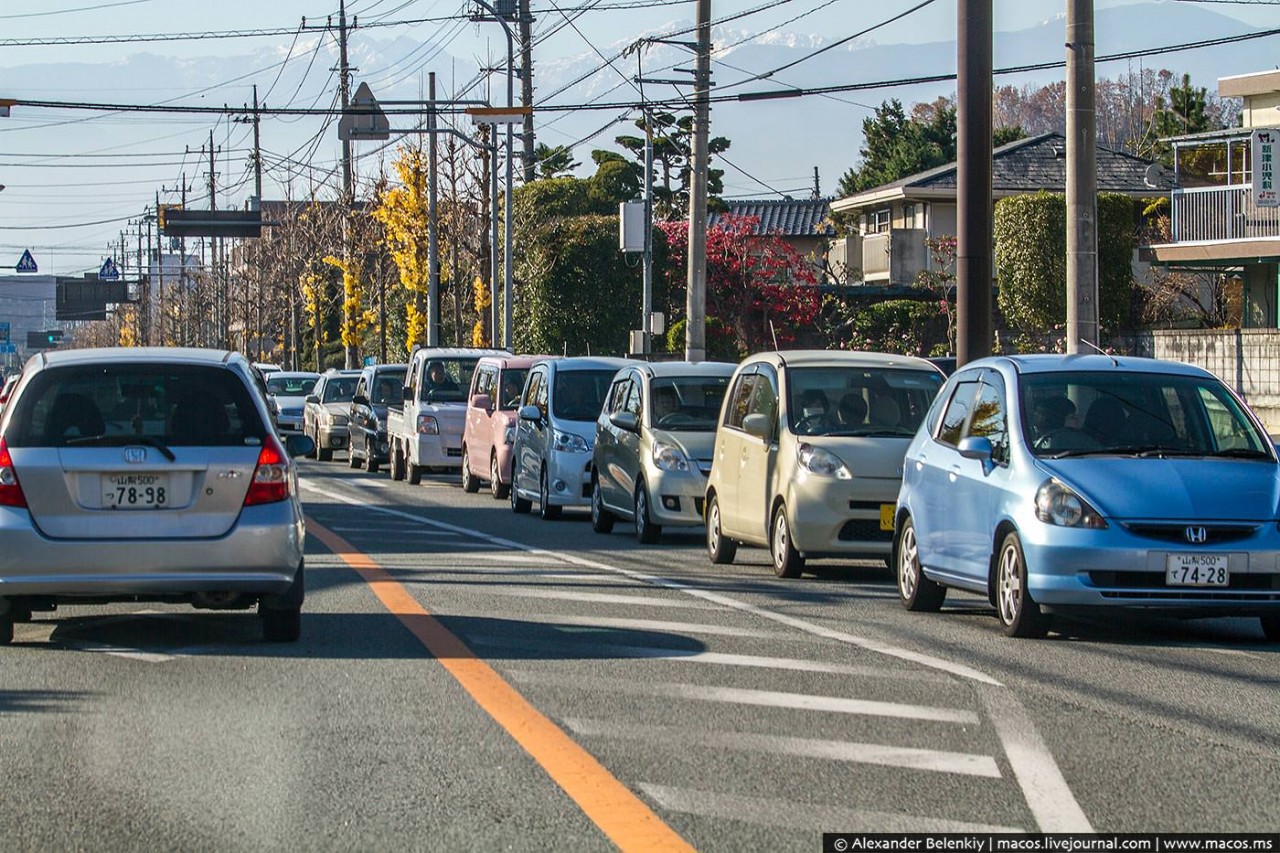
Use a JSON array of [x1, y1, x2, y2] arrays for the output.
[[511, 356, 636, 519]]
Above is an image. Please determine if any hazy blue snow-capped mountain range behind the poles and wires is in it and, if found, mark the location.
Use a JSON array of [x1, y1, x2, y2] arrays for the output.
[[0, 1, 1277, 224]]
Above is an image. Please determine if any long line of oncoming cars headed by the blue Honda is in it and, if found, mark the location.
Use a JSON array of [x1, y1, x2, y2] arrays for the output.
[[282, 350, 1280, 640]]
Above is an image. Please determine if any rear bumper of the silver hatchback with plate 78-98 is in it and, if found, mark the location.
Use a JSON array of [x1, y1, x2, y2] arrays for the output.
[[0, 501, 305, 598]]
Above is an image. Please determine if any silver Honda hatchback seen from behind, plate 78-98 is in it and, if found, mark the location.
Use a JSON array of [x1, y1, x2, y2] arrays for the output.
[[0, 348, 312, 643]]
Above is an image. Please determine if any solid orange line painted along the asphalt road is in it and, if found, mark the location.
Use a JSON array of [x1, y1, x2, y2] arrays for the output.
[[307, 516, 694, 850]]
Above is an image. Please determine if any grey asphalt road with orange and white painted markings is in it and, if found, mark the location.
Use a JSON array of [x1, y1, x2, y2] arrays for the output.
[[0, 457, 1280, 850]]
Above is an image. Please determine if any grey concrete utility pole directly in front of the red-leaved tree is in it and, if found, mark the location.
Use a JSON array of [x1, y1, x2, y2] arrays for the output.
[[686, 0, 712, 361]]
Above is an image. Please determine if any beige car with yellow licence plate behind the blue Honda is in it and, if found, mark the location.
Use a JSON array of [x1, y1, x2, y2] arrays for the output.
[[705, 351, 945, 578]]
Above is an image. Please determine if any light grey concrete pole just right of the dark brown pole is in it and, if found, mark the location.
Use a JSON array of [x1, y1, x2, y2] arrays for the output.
[[1066, 0, 1100, 353]]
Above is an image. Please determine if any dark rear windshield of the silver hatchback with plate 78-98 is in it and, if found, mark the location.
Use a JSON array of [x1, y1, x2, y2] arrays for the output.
[[5, 364, 266, 447]]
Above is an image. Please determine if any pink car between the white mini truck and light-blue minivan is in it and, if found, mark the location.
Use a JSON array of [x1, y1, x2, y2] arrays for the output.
[[462, 356, 549, 501]]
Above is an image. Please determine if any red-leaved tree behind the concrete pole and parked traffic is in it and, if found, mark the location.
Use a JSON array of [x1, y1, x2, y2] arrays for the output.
[[657, 214, 822, 357]]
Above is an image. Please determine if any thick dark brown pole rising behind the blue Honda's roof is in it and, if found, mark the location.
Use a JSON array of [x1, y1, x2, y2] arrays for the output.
[[956, 0, 995, 365]]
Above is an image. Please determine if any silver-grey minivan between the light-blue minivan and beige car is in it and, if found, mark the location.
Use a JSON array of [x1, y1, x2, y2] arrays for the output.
[[591, 361, 736, 544]]
